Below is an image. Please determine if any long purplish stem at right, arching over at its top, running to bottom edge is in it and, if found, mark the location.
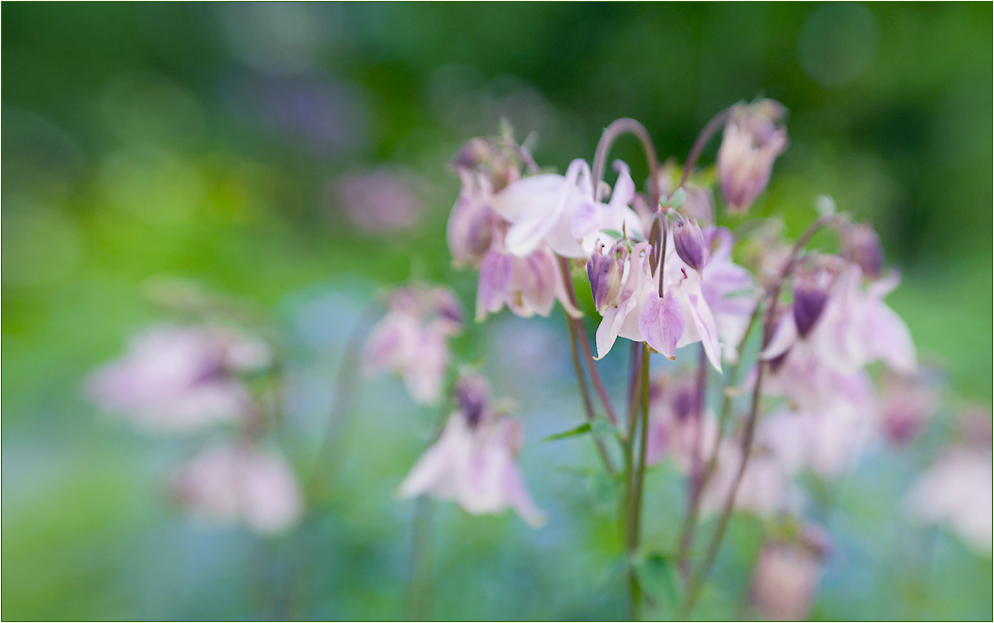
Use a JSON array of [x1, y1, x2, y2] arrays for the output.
[[679, 215, 844, 619]]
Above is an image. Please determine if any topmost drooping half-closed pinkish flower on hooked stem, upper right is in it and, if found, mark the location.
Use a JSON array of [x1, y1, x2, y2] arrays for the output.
[[718, 99, 787, 212]]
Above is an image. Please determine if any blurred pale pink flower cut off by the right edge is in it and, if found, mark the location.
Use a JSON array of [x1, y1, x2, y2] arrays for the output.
[[905, 446, 994, 556]]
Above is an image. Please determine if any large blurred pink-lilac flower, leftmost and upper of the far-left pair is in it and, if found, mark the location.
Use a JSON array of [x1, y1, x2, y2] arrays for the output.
[[87, 326, 270, 433]]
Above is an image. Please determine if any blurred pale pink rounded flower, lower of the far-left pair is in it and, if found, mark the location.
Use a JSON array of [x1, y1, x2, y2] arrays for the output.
[[170, 445, 303, 534]]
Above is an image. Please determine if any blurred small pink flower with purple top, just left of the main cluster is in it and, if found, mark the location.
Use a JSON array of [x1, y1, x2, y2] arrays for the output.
[[361, 287, 462, 405]]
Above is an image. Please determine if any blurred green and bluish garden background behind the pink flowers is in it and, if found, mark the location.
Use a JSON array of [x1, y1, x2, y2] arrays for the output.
[[2, 3, 994, 619]]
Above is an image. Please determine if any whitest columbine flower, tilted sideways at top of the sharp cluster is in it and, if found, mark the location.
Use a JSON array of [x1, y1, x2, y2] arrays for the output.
[[491, 159, 594, 257]]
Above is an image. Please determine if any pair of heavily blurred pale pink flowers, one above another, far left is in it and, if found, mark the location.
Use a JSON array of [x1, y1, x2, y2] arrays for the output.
[[87, 325, 303, 534]]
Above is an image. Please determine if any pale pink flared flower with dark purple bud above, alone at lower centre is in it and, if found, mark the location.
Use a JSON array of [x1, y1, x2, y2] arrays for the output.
[[399, 377, 545, 527]]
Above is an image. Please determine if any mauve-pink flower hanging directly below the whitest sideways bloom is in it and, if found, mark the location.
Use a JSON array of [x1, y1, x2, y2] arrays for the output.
[[476, 232, 582, 322]]
